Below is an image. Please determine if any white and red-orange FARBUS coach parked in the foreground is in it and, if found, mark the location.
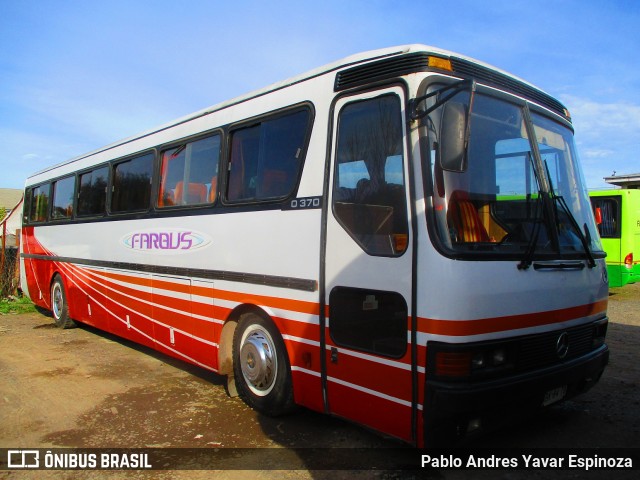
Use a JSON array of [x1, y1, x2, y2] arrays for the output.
[[21, 45, 608, 446]]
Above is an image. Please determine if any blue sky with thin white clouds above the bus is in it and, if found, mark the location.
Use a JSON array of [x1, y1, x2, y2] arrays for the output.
[[0, 0, 640, 188]]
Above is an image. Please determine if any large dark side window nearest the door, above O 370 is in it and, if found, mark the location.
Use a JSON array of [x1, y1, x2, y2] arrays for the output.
[[226, 110, 310, 202]]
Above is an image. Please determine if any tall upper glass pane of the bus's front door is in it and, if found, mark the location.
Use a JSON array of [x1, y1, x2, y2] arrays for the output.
[[333, 95, 409, 255]]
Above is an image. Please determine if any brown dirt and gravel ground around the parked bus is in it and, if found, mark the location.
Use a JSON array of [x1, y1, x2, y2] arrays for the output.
[[0, 284, 640, 479]]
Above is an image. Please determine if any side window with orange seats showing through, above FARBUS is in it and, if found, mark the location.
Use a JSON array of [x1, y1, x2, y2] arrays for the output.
[[158, 135, 220, 208]]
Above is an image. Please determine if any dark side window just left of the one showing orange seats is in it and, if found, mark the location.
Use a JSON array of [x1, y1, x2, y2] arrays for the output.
[[111, 153, 153, 213]]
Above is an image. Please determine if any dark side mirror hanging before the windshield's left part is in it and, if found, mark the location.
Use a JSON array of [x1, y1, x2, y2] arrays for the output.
[[440, 102, 467, 172]]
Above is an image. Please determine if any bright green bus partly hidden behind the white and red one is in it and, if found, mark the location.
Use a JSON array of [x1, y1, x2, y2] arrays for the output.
[[589, 189, 640, 287]]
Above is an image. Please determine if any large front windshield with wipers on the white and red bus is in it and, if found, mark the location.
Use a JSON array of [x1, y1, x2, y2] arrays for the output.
[[428, 88, 602, 259]]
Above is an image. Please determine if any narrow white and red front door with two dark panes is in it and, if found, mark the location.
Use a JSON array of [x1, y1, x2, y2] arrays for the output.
[[324, 87, 413, 441]]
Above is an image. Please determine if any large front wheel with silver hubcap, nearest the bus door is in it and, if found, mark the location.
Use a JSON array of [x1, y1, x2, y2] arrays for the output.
[[233, 313, 294, 417]]
